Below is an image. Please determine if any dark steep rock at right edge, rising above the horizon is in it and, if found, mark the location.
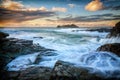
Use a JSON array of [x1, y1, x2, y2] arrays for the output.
[[107, 22, 120, 38]]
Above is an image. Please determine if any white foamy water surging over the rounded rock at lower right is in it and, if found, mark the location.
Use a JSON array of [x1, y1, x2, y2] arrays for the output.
[[80, 52, 120, 78]]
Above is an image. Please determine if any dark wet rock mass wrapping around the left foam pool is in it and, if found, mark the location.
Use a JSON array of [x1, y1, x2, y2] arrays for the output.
[[0, 33, 54, 80]]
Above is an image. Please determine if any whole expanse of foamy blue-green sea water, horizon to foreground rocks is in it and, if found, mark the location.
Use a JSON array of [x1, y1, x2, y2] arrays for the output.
[[1, 28, 120, 77]]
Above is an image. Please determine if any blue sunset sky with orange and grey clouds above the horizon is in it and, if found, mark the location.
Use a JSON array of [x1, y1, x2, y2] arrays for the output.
[[0, 0, 120, 27]]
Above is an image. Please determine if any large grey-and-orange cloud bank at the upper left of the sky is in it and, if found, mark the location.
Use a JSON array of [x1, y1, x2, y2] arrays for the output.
[[0, 0, 56, 23]]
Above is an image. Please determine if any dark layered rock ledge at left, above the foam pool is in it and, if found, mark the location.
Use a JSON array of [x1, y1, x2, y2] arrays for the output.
[[0, 38, 52, 69]]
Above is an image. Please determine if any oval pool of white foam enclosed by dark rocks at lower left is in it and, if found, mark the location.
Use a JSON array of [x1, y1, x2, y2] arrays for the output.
[[7, 53, 39, 71]]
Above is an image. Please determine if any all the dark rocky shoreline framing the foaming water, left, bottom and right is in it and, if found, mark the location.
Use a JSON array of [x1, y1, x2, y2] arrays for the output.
[[0, 22, 120, 80]]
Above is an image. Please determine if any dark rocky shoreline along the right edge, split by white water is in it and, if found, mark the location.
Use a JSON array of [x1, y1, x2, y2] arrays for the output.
[[97, 22, 120, 56]]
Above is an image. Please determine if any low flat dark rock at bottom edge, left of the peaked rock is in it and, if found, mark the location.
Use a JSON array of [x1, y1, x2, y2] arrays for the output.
[[17, 67, 52, 80]]
